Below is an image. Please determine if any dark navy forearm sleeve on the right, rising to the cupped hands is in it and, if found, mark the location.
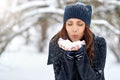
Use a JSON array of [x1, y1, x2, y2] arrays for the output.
[[76, 50, 96, 80]]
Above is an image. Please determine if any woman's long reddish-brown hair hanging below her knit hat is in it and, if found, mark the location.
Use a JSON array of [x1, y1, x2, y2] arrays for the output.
[[53, 24, 94, 63]]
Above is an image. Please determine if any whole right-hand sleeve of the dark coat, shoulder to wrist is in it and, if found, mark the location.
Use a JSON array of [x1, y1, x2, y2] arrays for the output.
[[76, 38, 106, 80]]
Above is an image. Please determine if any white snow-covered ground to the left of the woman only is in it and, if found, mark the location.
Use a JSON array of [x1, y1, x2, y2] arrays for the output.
[[0, 36, 54, 80]]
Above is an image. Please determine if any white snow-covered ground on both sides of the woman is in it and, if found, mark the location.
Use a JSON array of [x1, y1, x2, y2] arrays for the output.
[[0, 24, 120, 80]]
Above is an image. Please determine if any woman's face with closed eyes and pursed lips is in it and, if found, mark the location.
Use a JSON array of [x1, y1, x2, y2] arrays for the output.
[[66, 18, 85, 41]]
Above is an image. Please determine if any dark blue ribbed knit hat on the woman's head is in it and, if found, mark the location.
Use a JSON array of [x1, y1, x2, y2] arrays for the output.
[[63, 3, 92, 27]]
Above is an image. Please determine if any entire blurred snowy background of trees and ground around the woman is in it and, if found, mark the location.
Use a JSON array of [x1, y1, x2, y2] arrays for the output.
[[0, 0, 120, 80]]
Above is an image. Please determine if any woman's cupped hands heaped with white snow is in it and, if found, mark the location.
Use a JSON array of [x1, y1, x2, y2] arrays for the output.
[[58, 38, 85, 51]]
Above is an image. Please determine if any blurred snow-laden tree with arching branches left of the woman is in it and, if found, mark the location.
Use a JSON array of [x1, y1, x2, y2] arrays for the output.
[[0, 0, 63, 54]]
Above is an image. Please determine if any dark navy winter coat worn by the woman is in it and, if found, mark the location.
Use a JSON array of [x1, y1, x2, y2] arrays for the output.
[[48, 36, 106, 80]]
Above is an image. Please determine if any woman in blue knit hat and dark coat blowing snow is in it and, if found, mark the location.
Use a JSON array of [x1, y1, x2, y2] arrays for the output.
[[48, 3, 106, 80]]
